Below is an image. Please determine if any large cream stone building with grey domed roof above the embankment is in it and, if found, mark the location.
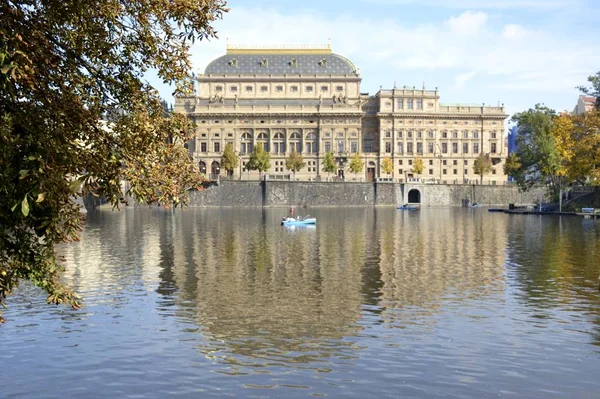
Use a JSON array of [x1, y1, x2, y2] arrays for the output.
[[175, 46, 507, 184]]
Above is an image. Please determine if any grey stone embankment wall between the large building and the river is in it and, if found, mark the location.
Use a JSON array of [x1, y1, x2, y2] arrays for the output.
[[182, 180, 548, 207]]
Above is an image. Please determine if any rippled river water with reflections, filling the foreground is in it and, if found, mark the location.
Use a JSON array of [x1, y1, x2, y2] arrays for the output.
[[0, 208, 600, 398]]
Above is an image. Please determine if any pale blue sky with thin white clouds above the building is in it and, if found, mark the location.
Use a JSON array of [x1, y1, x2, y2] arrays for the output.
[[149, 0, 600, 131]]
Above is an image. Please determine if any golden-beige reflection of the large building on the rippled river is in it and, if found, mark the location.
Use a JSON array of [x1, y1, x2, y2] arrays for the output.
[[58, 208, 600, 368]]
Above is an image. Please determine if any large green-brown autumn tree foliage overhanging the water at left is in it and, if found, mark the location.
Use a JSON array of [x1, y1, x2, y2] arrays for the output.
[[0, 0, 227, 319]]
